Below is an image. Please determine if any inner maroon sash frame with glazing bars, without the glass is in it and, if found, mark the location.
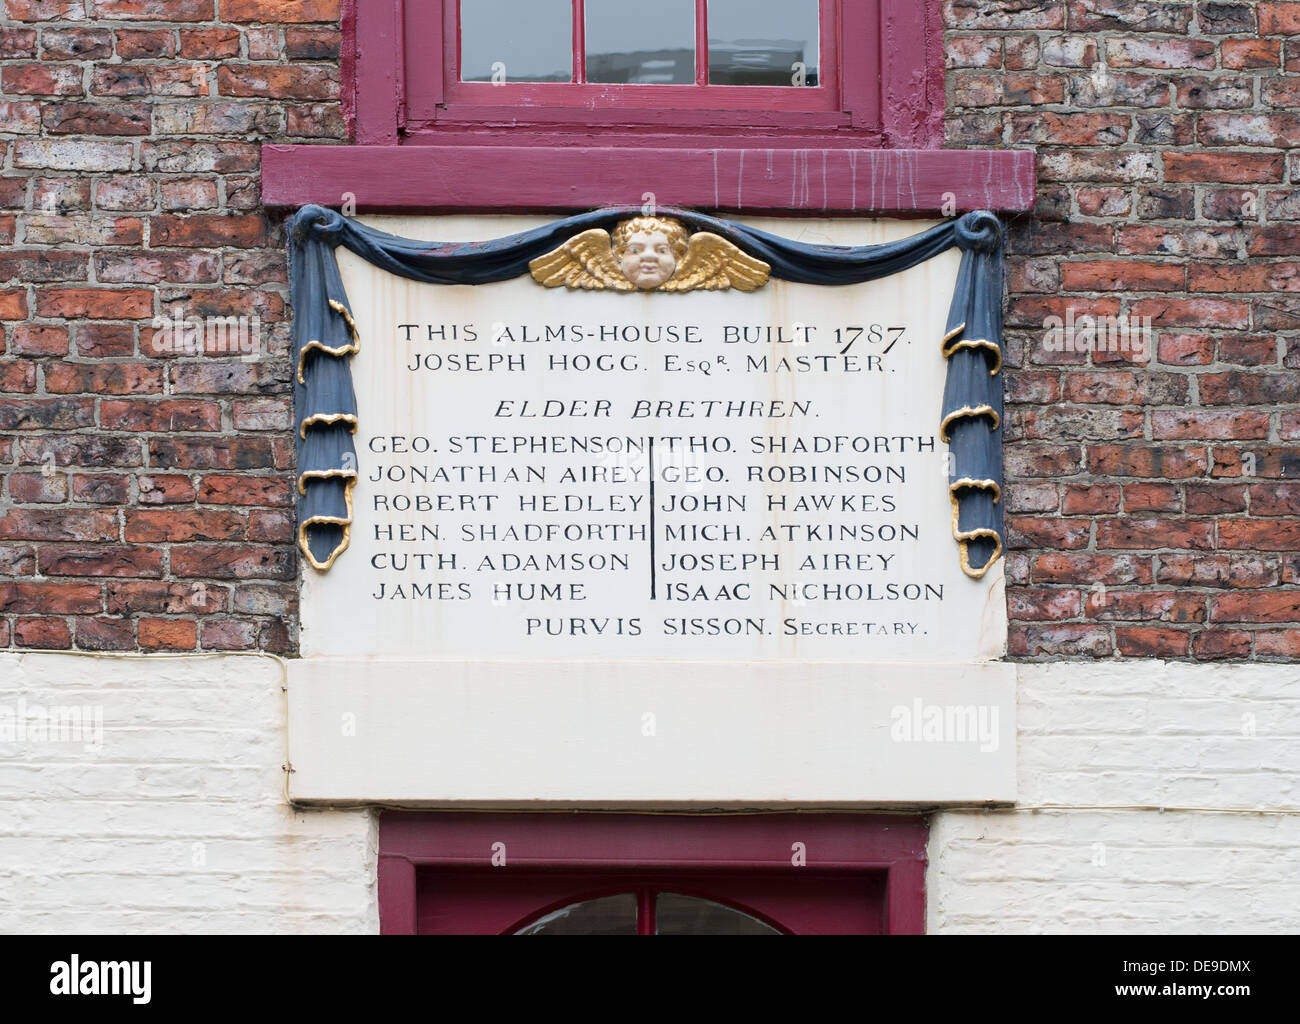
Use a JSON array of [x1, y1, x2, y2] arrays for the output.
[[421, 0, 847, 128]]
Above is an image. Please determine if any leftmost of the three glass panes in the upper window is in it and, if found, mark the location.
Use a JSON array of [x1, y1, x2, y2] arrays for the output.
[[460, 0, 573, 82]]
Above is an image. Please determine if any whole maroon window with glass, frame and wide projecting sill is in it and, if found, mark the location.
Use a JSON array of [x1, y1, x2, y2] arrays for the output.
[[261, 0, 1035, 214]]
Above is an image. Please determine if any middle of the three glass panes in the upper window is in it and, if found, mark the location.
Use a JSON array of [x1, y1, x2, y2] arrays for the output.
[[586, 0, 696, 86]]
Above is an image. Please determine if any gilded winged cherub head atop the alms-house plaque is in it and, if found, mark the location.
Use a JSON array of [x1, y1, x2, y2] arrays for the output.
[[529, 217, 772, 291]]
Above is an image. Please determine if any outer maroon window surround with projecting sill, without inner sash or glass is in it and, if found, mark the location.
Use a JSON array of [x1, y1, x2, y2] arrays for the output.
[[261, 0, 1035, 216]]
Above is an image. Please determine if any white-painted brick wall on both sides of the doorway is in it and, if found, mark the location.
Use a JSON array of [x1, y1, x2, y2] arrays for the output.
[[0, 654, 1300, 933]]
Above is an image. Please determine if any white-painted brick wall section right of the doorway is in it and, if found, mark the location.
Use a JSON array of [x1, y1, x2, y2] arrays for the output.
[[927, 661, 1300, 933]]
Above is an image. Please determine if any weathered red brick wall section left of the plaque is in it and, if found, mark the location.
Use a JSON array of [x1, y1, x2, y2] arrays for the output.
[[0, 0, 343, 652]]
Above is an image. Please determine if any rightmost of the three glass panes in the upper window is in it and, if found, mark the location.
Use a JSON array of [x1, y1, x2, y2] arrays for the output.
[[709, 0, 820, 86]]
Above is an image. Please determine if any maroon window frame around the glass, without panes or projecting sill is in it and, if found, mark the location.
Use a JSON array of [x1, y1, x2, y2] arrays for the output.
[[342, 0, 904, 147]]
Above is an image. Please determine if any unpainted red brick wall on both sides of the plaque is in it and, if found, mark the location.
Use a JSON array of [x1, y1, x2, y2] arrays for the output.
[[0, 0, 1300, 660]]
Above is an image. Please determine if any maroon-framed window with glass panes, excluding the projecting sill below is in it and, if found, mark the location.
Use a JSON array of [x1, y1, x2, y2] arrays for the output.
[[377, 0, 944, 147]]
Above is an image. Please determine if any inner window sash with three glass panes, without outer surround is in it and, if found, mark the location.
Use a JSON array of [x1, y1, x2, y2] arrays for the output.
[[444, 0, 832, 120]]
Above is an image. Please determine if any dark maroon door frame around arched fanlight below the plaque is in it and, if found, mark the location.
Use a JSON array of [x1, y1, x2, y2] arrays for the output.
[[378, 811, 928, 934]]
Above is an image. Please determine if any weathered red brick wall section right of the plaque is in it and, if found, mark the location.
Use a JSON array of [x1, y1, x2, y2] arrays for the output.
[[944, 0, 1300, 660]]
